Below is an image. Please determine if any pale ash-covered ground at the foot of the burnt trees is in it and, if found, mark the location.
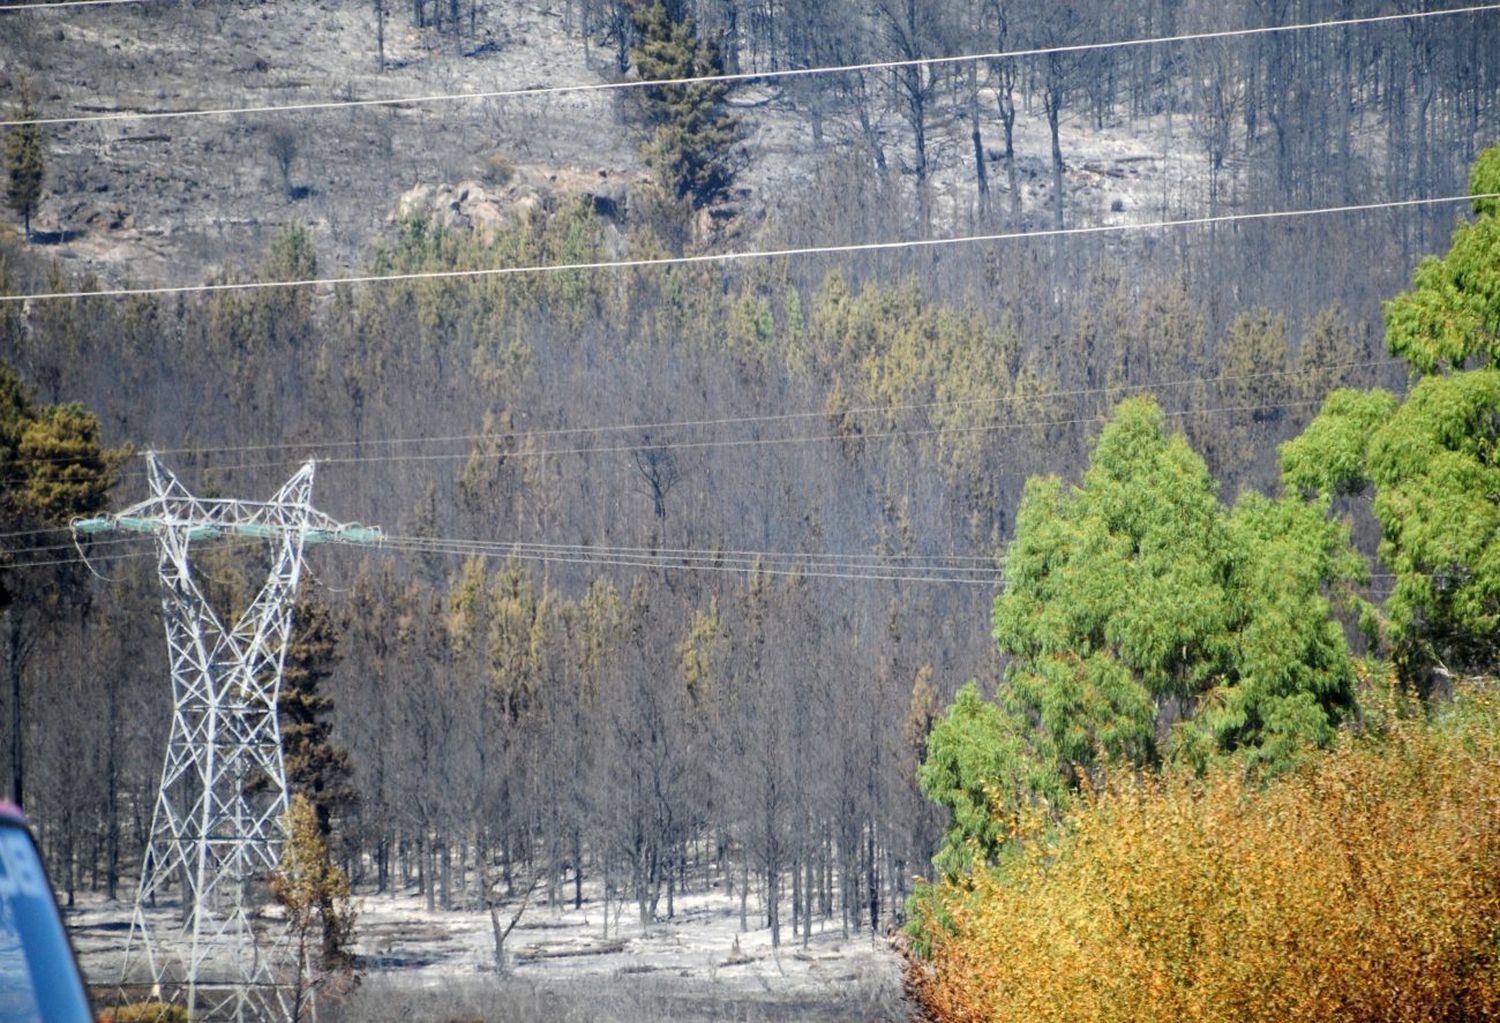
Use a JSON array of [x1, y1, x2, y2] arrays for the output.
[[68, 891, 911, 1023]]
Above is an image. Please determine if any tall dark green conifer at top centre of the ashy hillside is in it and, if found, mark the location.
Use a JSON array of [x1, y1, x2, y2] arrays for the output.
[[630, 0, 740, 207]]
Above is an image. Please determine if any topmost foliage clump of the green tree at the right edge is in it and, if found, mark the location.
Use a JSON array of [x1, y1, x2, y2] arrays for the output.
[[1383, 146, 1500, 374]]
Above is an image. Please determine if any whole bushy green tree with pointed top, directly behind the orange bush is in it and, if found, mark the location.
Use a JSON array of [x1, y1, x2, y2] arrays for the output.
[[923, 398, 1364, 872]]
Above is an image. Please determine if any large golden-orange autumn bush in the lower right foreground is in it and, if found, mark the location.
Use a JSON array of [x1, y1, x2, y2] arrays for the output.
[[911, 684, 1500, 1023]]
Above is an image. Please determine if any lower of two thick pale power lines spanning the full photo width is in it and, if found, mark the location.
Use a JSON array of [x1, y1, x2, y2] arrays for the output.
[[0, 192, 1500, 303]]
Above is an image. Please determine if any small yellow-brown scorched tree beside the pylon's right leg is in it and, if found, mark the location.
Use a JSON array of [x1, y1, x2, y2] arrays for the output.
[[272, 792, 356, 1023]]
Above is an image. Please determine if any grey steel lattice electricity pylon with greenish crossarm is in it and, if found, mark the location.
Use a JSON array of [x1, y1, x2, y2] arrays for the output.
[[74, 452, 381, 1020]]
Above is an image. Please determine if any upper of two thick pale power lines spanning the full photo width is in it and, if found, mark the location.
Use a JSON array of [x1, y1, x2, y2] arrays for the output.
[[0, 0, 1500, 128]]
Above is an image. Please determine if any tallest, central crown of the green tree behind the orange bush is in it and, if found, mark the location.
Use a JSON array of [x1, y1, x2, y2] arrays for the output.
[[995, 399, 1230, 783]]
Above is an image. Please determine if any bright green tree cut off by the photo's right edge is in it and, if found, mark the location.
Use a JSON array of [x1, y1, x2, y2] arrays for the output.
[[1281, 146, 1500, 693]]
